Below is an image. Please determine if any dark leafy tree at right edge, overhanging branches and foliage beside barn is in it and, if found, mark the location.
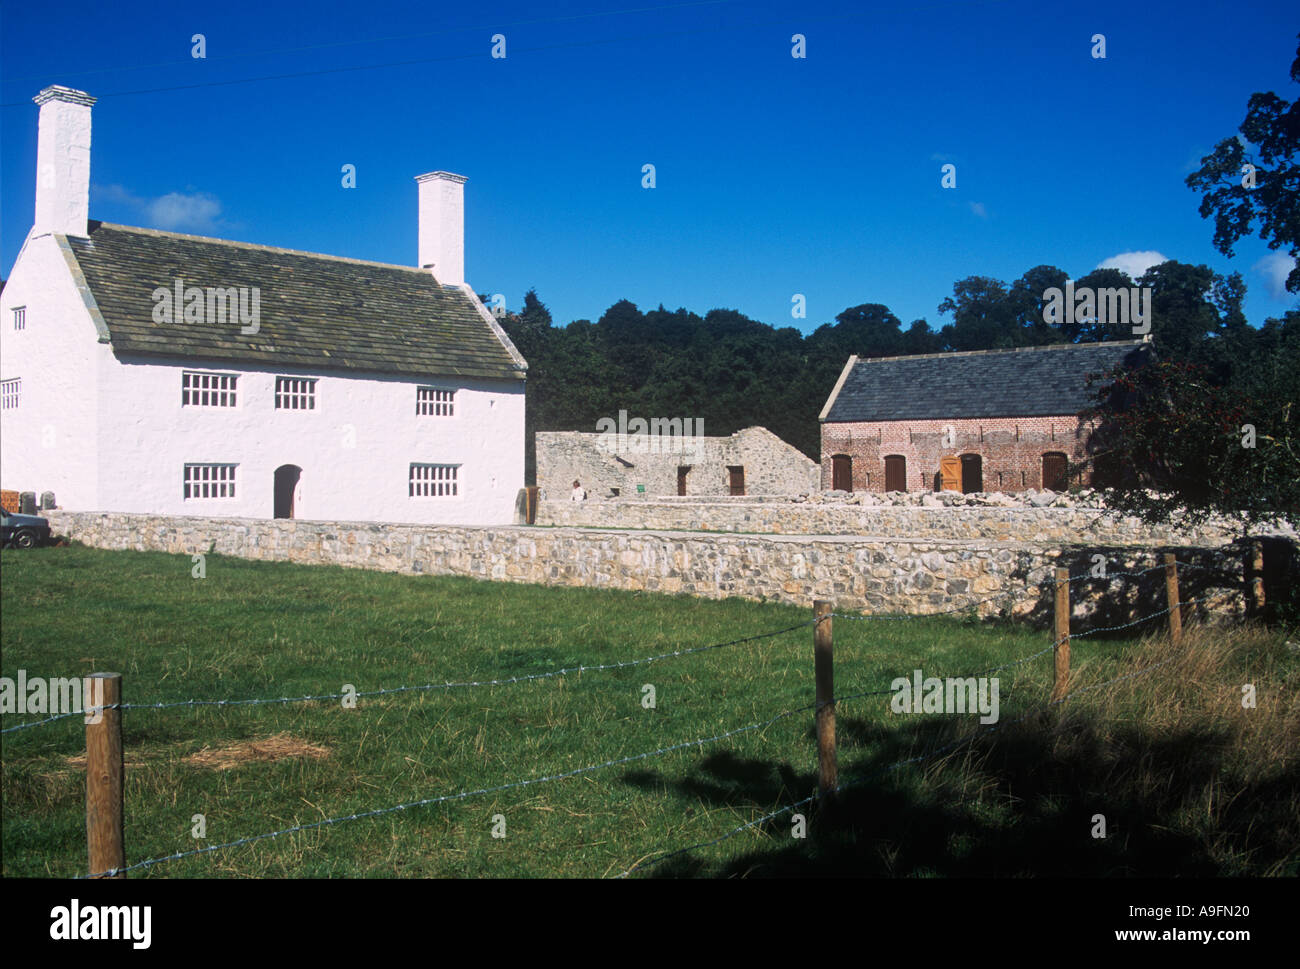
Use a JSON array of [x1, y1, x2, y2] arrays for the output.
[[1084, 39, 1300, 559]]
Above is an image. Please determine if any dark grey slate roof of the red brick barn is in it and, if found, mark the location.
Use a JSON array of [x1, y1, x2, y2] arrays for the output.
[[822, 339, 1151, 423]]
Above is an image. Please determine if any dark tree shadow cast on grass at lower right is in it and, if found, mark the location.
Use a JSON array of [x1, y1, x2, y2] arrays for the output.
[[623, 713, 1296, 878]]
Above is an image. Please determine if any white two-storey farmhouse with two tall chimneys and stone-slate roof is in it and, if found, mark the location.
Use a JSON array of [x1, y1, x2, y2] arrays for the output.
[[0, 86, 528, 524]]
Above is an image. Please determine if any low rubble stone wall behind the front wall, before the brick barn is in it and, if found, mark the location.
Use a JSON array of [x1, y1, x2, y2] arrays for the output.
[[537, 498, 1258, 546]]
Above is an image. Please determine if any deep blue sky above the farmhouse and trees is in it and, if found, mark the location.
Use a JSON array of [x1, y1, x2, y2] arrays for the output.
[[0, 0, 1300, 332]]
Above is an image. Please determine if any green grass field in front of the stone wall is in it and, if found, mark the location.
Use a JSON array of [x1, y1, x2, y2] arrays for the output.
[[0, 546, 1300, 878]]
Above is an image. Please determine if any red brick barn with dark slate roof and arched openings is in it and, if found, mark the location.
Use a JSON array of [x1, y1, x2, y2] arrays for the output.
[[820, 341, 1151, 493]]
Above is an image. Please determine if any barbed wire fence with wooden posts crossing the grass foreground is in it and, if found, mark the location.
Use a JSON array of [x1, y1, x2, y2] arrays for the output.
[[0, 543, 1258, 878]]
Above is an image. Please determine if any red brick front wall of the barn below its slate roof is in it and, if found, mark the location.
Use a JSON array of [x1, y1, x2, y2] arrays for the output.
[[822, 415, 1089, 492]]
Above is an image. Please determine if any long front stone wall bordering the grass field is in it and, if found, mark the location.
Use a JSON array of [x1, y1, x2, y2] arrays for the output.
[[48, 511, 1242, 624]]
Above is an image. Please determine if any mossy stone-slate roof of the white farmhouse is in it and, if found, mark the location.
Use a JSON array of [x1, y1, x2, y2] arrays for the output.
[[66, 221, 527, 380]]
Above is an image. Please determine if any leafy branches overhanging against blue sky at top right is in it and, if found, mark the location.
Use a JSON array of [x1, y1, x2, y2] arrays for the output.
[[1187, 35, 1300, 293]]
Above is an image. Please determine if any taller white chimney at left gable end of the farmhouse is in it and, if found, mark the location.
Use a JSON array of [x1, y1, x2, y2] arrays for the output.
[[33, 85, 96, 235]]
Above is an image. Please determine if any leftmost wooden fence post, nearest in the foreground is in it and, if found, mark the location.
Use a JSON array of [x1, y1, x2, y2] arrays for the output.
[[82, 672, 126, 878]]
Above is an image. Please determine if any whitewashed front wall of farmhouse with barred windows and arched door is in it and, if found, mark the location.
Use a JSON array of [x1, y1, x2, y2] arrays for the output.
[[94, 358, 524, 524]]
